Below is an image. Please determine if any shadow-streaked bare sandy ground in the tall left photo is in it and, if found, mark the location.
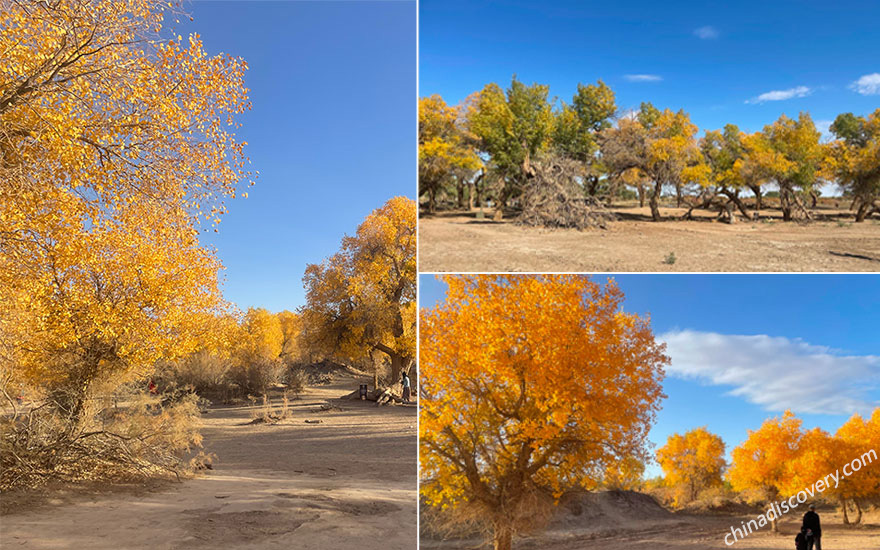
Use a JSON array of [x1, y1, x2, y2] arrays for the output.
[[0, 378, 418, 550]]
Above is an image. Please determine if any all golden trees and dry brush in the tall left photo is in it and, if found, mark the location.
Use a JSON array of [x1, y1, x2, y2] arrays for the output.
[[0, 0, 416, 491]]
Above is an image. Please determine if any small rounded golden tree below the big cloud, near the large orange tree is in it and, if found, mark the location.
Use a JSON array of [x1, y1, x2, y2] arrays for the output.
[[657, 427, 726, 506]]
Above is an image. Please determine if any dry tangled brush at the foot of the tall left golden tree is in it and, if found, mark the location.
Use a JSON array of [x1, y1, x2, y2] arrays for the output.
[[0, 392, 201, 491]]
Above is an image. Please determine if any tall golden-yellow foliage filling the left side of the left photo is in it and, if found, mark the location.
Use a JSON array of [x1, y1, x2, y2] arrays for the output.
[[0, 0, 250, 415]]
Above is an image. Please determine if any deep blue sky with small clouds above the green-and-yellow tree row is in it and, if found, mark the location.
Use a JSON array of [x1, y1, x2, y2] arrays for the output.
[[419, 0, 880, 138]]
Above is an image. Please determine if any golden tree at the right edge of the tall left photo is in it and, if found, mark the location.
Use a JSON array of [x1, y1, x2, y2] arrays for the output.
[[302, 197, 416, 382]]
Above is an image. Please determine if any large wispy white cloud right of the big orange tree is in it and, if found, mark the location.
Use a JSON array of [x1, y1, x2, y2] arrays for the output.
[[660, 330, 880, 415]]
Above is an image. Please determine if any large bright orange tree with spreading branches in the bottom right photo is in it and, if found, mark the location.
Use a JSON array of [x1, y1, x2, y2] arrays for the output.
[[419, 275, 668, 550]]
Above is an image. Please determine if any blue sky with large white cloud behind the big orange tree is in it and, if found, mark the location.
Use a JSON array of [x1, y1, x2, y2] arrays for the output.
[[419, 274, 880, 475]]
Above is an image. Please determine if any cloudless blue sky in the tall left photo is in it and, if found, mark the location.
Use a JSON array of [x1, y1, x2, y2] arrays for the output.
[[175, 1, 417, 311]]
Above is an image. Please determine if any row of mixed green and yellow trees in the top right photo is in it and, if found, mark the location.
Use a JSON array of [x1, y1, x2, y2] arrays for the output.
[[419, 77, 880, 225]]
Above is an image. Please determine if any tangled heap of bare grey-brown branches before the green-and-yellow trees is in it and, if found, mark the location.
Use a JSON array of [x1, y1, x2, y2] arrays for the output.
[[517, 154, 615, 230]]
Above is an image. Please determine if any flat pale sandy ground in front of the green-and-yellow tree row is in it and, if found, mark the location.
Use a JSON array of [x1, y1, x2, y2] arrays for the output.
[[419, 206, 880, 272]]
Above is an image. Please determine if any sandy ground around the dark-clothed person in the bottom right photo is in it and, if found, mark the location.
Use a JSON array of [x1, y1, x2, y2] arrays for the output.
[[420, 510, 880, 550]]
